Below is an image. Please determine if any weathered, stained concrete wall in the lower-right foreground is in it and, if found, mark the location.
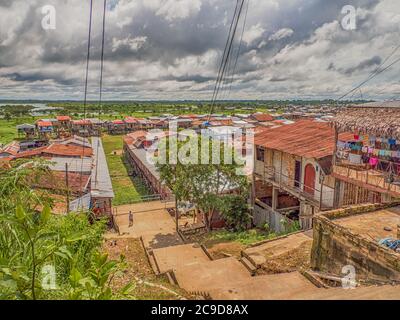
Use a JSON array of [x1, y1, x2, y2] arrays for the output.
[[311, 204, 400, 281]]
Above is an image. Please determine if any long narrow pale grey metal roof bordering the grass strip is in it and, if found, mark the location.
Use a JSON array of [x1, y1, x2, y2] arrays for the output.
[[91, 137, 114, 198]]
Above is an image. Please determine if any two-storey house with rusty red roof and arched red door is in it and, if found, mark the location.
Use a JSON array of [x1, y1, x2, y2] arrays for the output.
[[252, 120, 350, 232]]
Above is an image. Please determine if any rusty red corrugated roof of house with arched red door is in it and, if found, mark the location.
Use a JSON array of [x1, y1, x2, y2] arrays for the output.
[[254, 120, 353, 159]]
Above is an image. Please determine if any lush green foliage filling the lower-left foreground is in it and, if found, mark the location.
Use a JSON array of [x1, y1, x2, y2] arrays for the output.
[[0, 163, 131, 300]]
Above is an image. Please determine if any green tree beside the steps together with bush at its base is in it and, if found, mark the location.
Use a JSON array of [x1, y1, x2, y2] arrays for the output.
[[157, 137, 250, 231]]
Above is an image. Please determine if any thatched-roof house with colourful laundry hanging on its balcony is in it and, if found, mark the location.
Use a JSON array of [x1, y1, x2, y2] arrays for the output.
[[333, 101, 400, 205]]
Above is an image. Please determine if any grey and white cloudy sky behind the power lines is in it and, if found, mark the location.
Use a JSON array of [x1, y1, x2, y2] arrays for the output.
[[0, 0, 400, 100]]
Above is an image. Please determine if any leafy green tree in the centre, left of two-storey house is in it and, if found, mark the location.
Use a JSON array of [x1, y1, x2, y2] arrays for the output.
[[158, 134, 248, 230]]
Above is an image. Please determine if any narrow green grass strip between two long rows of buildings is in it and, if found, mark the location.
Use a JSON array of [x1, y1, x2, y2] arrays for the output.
[[103, 135, 149, 206]]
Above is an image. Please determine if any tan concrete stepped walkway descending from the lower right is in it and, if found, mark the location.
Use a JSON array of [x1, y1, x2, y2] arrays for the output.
[[111, 201, 400, 300]]
